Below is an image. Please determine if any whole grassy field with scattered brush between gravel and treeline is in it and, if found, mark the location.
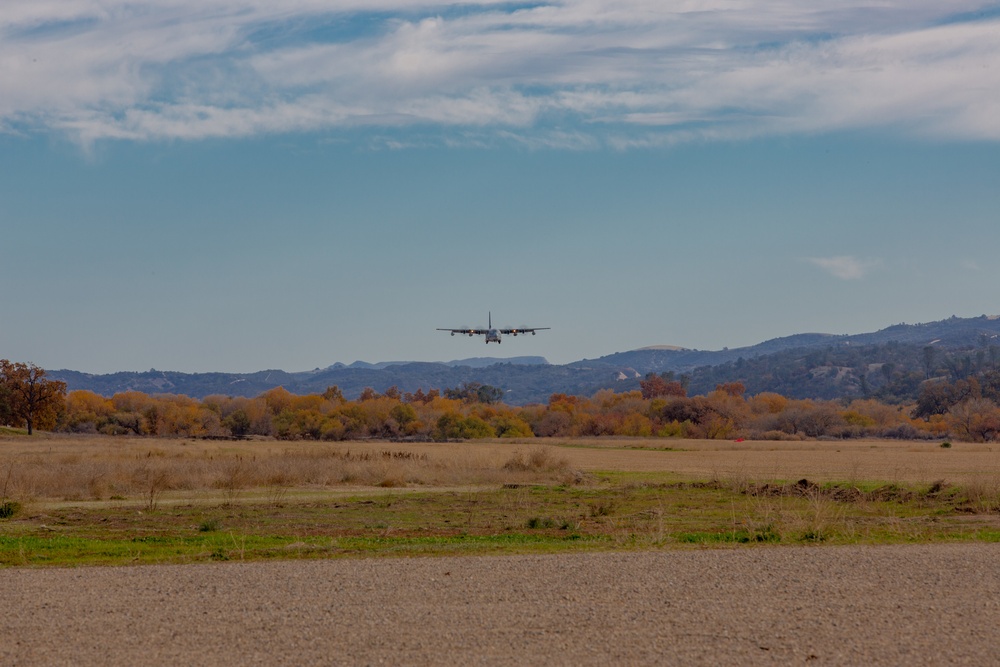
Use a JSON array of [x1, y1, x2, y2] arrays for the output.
[[0, 434, 1000, 566]]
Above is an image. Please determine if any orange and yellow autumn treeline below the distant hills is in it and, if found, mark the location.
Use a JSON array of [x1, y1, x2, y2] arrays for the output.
[[45, 376, 1000, 442]]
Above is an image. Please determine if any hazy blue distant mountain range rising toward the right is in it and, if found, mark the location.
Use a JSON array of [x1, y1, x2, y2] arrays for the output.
[[48, 315, 1000, 405]]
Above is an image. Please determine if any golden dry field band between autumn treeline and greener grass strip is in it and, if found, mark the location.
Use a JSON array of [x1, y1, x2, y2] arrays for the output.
[[0, 435, 1000, 505]]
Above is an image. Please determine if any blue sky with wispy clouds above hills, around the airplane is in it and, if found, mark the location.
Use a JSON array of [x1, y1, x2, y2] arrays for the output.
[[0, 0, 1000, 373]]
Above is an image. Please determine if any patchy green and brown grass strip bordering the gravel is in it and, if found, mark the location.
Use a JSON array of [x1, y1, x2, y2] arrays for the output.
[[0, 480, 1000, 566]]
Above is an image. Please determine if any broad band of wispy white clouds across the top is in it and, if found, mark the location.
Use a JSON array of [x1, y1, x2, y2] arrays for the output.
[[0, 0, 1000, 148]]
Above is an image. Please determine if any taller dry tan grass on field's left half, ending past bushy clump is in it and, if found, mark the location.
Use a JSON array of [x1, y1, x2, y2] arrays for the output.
[[0, 440, 574, 508]]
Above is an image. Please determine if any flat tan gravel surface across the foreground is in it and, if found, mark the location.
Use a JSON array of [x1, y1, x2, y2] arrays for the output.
[[0, 544, 1000, 665]]
